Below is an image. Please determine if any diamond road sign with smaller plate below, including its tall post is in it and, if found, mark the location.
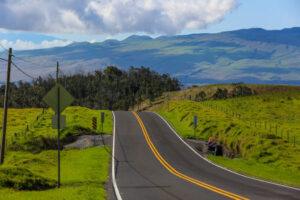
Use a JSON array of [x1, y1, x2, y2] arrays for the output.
[[43, 62, 74, 188]]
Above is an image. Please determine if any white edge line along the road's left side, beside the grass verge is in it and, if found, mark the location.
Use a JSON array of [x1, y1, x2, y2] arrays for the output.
[[111, 111, 122, 200]]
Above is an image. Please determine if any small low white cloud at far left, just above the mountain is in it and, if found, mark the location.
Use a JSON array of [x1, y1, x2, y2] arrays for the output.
[[0, 40, 72, 50]]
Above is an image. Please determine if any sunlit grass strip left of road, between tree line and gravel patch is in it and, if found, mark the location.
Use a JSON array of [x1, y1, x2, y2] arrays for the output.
[[0, 106, 112, 143]]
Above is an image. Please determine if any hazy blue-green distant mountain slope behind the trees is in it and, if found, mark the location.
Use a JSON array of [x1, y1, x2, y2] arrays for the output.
[[10, 28, 300, 84]]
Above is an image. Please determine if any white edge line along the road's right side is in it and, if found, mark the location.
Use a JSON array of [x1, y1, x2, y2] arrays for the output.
[[151, 112, 300, 191]]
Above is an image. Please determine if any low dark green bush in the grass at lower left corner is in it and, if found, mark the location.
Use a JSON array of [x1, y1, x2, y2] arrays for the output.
[[0, 167, 56, 190]]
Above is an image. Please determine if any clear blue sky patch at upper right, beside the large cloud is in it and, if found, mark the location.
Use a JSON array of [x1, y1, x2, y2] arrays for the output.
[[195, 0, 300, 32]]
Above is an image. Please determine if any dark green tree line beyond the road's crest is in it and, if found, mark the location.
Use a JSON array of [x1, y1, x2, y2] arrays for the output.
[[0, 66, 181, 110]]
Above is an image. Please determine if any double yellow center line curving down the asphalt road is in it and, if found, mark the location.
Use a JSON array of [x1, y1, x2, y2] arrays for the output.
[[132, 112, 248, 200]]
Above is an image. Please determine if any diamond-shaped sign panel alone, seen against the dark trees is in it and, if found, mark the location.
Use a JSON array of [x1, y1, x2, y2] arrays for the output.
[[43, 83, 74, 112]]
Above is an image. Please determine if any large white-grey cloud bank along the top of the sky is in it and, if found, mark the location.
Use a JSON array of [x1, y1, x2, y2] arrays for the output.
[[0, 0, 237, 34]]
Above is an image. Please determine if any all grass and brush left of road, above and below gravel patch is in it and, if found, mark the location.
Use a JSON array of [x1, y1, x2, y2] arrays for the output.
[[0, 107, 112, 199]]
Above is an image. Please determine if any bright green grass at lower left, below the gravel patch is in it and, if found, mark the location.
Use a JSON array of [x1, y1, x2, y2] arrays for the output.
[[0, 147, 110, 200]]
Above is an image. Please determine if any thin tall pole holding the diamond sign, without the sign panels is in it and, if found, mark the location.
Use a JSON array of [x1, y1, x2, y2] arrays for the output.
[[56, 62, 60, 188]]
